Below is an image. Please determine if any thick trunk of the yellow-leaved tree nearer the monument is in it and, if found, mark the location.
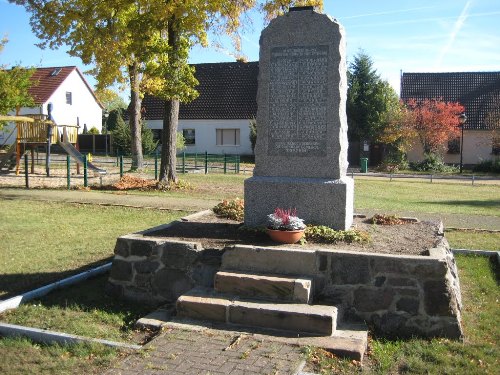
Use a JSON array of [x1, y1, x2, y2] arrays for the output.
[[159, 100, 179, 184]]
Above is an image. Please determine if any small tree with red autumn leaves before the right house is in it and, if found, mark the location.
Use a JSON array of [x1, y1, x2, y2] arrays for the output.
[[406, 99, 465, 154]]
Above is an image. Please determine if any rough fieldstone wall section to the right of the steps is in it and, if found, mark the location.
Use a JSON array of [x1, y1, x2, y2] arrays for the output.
[[314, 240, 462, 338]]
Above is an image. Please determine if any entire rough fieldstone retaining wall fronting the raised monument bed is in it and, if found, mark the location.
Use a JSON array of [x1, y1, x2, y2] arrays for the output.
[[108, 234, 462, 338]]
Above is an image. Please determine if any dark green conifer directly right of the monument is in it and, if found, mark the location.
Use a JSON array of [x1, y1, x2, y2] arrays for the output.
[[346, 51, 399, 146]]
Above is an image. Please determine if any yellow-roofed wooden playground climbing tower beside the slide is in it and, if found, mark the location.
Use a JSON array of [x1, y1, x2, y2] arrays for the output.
[[0, 115, 79, 176]]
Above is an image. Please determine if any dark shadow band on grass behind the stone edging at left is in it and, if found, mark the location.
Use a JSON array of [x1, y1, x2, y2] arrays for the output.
[[0, 257, 113, 300]]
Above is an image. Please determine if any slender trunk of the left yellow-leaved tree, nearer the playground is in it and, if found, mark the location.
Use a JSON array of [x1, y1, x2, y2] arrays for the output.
[[129, 62, 144, 170]]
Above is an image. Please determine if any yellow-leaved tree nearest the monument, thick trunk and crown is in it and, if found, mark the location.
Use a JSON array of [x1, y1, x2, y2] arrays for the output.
[[149, 0, 323, 184]]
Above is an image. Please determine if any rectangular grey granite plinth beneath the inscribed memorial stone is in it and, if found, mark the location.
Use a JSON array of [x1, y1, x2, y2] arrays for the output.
[[245, 176, 354, 230]]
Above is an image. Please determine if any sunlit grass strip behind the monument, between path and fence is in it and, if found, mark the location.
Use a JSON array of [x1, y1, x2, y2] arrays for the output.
[[100, 174, 500, 217]]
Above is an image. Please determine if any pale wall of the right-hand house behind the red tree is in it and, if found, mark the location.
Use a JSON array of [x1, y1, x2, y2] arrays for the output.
[[408, 130, 497, 165]]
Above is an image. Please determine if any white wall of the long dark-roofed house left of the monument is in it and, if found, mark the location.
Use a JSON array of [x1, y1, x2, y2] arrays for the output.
[[146, 119, 252, 155]]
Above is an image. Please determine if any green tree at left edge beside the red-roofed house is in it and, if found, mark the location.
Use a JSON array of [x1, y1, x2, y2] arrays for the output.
[[0, 38, 35, 117]]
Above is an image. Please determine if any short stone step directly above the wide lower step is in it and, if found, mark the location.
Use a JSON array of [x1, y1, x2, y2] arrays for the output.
[[214, 271, 312, 304]]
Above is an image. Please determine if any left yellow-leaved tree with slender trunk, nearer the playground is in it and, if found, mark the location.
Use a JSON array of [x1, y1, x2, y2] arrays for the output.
[[9, 0, 165, 169]]
